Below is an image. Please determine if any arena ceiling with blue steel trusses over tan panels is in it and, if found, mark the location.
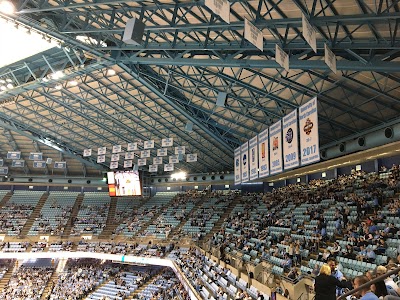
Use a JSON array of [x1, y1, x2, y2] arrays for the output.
[[0, 0, 400, 176]]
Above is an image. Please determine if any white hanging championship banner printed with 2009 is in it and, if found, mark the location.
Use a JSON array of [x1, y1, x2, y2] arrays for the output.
[[282, 109, 299, 170]]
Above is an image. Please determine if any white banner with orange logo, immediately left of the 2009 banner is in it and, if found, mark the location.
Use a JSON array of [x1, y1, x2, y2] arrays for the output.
[[269, 120, 283, 175]]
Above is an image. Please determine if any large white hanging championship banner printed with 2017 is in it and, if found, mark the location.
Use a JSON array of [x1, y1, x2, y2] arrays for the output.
[[299, 98, 320, 166]]
